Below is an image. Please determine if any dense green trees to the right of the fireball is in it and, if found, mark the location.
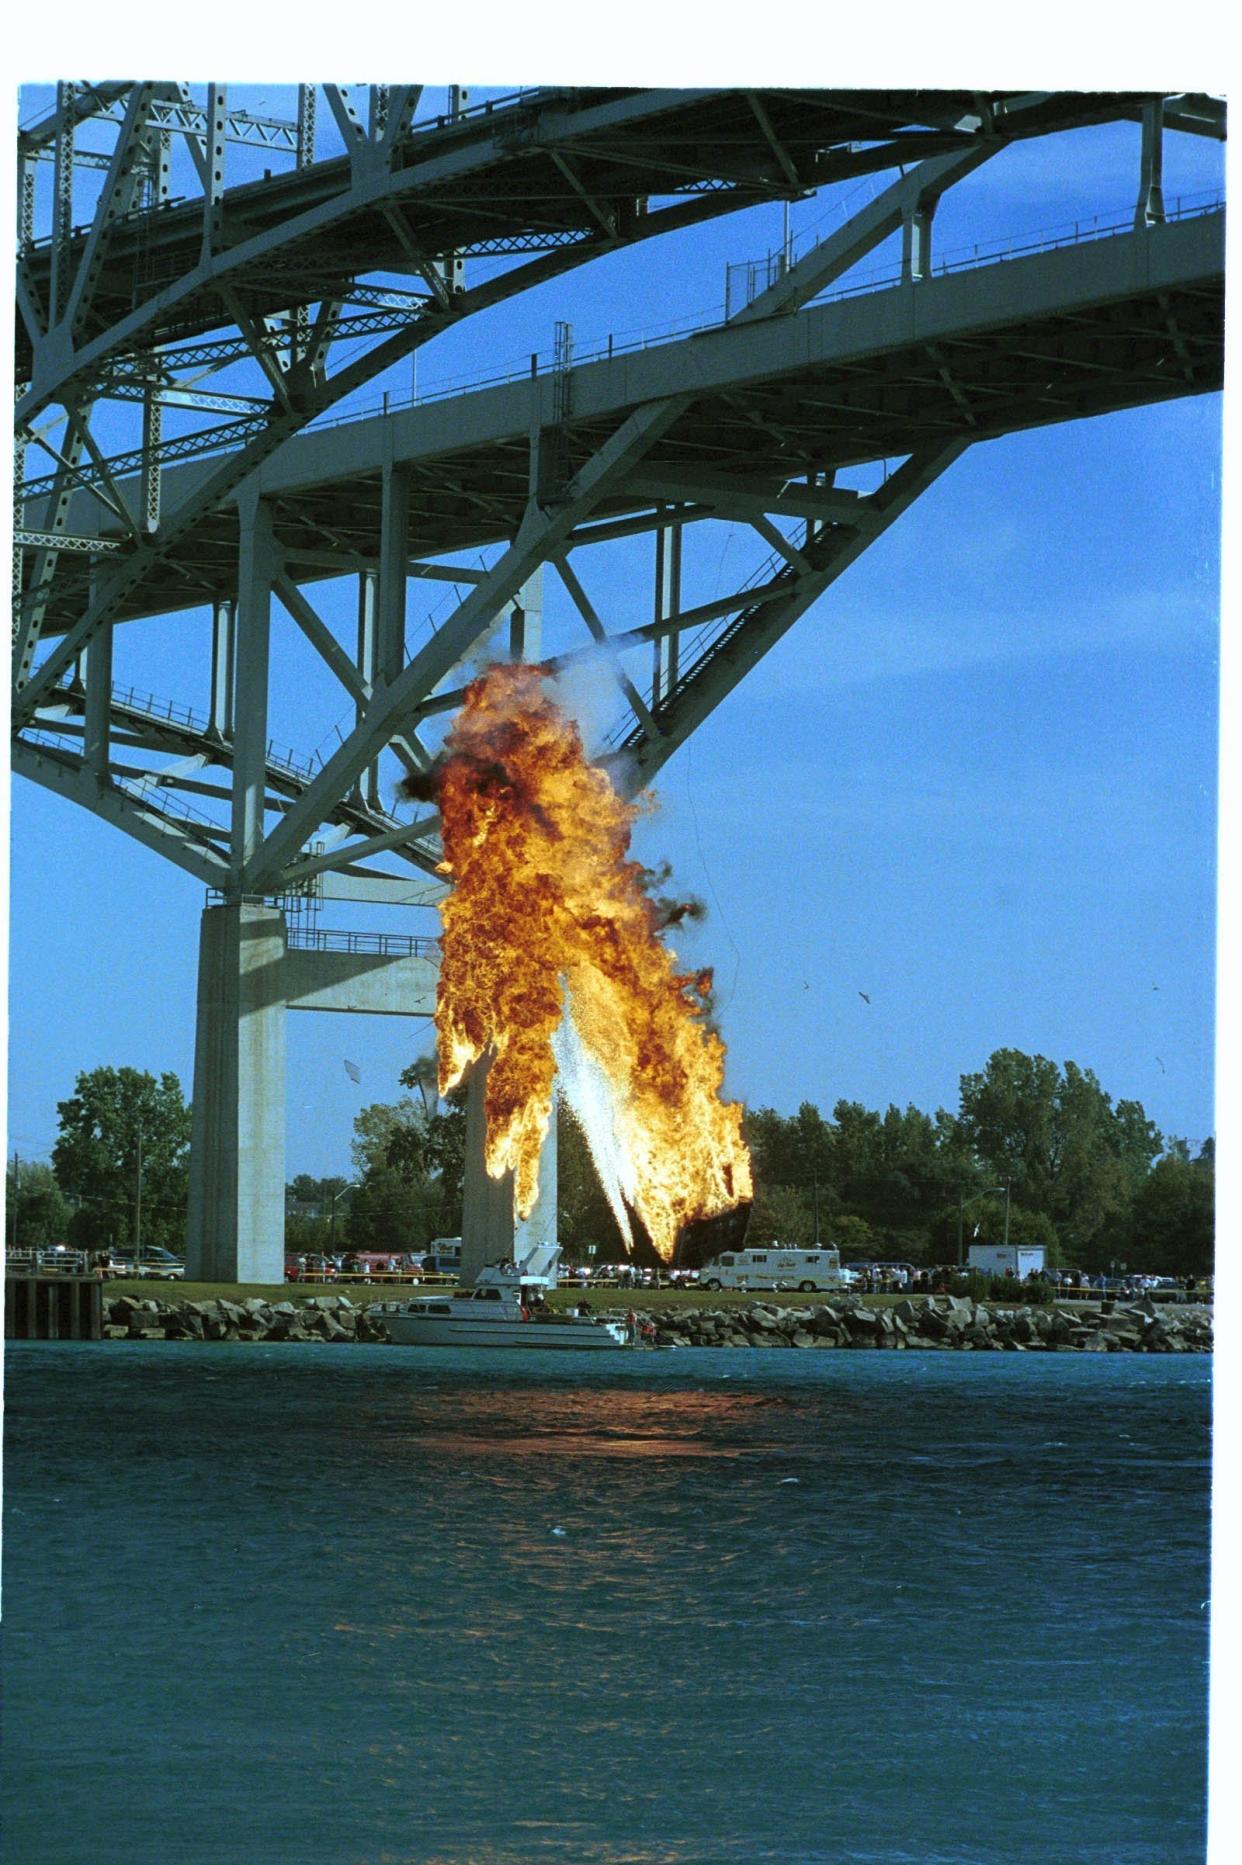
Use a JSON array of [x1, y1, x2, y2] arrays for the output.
[[734, 1048, 1214, 1276]]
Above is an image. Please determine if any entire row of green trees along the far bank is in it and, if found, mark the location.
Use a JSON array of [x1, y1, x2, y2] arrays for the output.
[[6, 1048, 1214, 1276]]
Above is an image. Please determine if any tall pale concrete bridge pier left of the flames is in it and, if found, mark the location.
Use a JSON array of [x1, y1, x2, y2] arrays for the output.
[[186, 901, 285, 1283]]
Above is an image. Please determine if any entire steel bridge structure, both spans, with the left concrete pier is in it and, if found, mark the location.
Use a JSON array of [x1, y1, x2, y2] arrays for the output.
[[13, 84, 1225, 1274]]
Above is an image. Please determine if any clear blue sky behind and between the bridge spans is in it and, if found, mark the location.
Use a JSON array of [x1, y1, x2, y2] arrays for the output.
[[9, 88, 1220, 1175]]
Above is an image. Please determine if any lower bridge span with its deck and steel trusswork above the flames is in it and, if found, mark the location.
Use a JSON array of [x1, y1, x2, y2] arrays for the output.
[[15, 200, 1223, 906]]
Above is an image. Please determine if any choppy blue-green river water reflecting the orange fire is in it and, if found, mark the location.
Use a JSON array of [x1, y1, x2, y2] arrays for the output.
[[4, 1343, 1210, 1865]]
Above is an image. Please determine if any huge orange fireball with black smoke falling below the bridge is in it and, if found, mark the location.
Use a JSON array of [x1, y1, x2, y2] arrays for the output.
[[436, 666, 752, 1261]]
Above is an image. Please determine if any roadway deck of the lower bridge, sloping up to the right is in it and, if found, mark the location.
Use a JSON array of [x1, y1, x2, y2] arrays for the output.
[[36, 211, 1223, 634]]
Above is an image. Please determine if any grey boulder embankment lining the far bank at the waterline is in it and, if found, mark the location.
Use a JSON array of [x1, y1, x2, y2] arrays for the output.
[[103, 1294, 1212, 1354]]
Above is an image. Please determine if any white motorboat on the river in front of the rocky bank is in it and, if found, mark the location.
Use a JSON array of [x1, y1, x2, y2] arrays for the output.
[[371, 1251, 632, 1352]]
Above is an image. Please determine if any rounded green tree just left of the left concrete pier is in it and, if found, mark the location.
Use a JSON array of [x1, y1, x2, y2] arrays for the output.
[[52, 1069, 190, 1250]]
